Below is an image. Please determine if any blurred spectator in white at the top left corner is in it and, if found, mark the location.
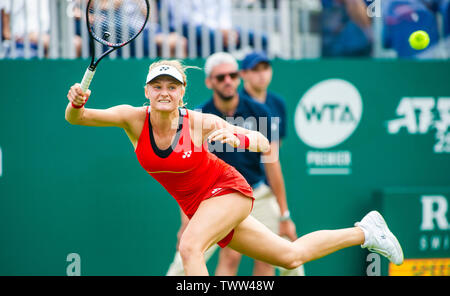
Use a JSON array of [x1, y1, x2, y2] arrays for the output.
[[0, 0, 50, 57]]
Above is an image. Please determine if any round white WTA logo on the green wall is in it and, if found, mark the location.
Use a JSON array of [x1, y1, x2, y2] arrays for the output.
[[295, 79, 363, 149]]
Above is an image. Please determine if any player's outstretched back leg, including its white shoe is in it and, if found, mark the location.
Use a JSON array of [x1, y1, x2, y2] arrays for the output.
[[229, 211, 403, 269]]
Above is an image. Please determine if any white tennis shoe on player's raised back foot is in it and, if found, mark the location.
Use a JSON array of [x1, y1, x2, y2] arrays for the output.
[[355, 211, 403, 265]]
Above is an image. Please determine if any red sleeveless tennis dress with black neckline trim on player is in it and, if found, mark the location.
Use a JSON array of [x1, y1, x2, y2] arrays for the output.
[[136, 108, 254, 248]]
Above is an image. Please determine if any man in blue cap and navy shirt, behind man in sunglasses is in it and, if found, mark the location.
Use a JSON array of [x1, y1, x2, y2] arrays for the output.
[[239, 52, 305, 276]]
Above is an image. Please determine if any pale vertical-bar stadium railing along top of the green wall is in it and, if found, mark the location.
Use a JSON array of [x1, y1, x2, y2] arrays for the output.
[[0, 0, 321, 59]]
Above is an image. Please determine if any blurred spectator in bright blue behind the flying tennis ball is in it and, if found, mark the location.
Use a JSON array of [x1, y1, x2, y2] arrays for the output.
[[383, 0, 439, 58]]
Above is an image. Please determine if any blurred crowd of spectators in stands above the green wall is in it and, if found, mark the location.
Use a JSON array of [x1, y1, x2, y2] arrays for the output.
[[0, 0, 450, 58]]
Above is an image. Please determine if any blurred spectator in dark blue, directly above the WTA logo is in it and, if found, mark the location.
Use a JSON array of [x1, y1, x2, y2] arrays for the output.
[[321, 0, 373, 57]]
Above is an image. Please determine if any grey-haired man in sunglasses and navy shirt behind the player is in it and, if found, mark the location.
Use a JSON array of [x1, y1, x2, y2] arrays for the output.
[[167, 52, 297, 275]]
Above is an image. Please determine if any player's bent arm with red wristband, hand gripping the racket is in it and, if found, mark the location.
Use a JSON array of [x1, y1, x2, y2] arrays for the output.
[[66, 83, 134, 130]]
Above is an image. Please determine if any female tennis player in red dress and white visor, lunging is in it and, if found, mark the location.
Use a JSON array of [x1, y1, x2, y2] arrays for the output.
[[66, 61, 403, 275]]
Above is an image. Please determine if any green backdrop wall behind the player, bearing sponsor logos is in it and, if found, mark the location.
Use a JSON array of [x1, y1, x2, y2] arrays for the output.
[[0, 60, 450, 275]]
